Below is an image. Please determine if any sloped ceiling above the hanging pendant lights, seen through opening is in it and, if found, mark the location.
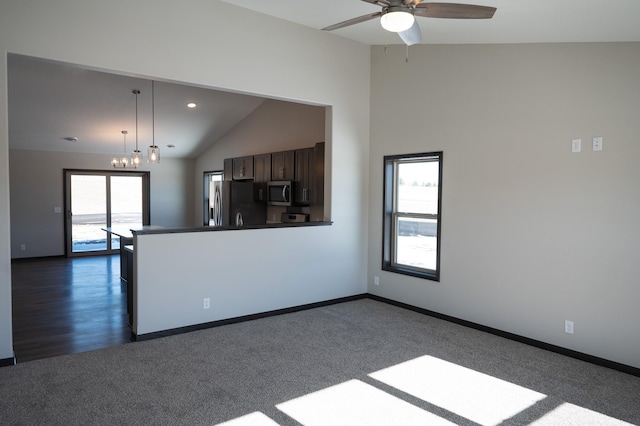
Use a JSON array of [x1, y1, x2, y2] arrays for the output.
[[8, 55, 264, 158]]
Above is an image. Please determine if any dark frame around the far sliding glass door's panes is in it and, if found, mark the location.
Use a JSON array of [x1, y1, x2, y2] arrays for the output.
[[63, 169, 151, 257]]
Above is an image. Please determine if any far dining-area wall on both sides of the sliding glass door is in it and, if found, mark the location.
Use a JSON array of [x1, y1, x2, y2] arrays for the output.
[[9, 150, 194, 259]]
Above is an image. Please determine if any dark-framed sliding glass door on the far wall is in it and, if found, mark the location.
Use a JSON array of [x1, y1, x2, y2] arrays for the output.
[[65, 170, 149, 256]]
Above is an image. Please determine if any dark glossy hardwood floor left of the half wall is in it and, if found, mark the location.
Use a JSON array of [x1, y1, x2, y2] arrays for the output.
[[11, 255, 131, 363]]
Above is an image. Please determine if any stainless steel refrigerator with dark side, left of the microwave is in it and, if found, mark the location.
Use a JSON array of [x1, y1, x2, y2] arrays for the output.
[[209, 181, 267, 226]]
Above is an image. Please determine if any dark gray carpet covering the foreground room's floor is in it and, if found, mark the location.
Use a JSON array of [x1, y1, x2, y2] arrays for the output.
[[0, 299, 640, 425]]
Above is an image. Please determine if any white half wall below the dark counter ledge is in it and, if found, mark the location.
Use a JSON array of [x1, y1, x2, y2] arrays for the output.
[[133, 226, 366, 335]]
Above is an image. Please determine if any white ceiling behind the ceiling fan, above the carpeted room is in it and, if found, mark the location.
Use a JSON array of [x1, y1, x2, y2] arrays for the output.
[[223, 0, 640, 45]]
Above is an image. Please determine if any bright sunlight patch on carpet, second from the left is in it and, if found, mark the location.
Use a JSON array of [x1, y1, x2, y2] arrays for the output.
[[276, 380, 454, 426]]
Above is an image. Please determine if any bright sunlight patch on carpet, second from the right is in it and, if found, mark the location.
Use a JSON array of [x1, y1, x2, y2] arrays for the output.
[[369, 356, 546, 425]]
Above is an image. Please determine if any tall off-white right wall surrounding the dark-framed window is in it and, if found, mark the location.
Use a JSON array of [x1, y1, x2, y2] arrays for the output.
[[368, 43, 640, 367]]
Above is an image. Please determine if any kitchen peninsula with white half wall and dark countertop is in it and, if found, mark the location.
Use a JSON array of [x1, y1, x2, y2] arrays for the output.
[[125, 221, 333, 341]]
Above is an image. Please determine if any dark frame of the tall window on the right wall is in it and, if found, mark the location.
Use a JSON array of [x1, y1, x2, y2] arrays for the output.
[[382, 151, 444, 281]]
